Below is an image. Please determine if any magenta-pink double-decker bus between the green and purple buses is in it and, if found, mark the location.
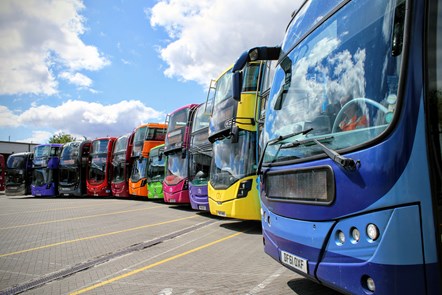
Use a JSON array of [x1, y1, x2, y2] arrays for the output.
[[163, 104, 198, 204]]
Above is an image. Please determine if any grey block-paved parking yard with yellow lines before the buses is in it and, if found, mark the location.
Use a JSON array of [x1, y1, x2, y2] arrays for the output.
[[0, 194, 336, 295]]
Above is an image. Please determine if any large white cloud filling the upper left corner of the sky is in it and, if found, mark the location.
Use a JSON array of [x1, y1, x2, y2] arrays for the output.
[[0, 0, 109, 95]]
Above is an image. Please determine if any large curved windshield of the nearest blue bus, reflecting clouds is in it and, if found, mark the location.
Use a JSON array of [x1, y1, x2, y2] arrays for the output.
[[263, 1, 405, 162]]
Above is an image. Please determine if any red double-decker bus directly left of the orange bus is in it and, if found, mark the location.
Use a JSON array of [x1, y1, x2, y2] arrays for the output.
[[111, 132, 135, 197]]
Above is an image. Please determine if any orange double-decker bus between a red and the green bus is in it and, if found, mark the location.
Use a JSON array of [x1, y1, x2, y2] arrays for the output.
[[129, 123, 167, 198]]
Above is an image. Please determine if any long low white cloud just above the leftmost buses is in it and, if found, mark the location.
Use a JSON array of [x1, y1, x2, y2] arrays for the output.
[[0, 100, 165, 142]]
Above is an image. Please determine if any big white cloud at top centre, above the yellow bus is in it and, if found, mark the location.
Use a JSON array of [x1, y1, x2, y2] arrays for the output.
[[146, 0, 303, 85]]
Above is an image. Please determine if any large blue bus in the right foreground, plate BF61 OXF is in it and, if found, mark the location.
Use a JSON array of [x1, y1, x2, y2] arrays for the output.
[[233, 0, 442, 294]]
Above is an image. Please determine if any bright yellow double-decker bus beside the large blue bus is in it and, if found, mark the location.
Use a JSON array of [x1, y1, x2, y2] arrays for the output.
[[208, 61, 271, 220]]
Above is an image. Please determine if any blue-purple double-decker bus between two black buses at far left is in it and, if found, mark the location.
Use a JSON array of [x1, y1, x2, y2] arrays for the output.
[[31, 143, 63, 197]]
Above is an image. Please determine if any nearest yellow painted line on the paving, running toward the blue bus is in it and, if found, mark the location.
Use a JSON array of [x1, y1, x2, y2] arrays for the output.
[[70, 232, 243, 295]]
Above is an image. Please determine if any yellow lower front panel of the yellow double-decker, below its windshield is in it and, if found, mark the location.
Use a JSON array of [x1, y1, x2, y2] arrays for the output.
[[208, 176, 261, 220]]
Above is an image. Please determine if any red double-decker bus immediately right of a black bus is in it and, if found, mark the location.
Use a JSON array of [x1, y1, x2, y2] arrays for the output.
[[86, 137, 117, 197]]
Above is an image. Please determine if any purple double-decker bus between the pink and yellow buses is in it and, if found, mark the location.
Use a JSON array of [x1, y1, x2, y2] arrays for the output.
[[189, 103, 212, 211]]
